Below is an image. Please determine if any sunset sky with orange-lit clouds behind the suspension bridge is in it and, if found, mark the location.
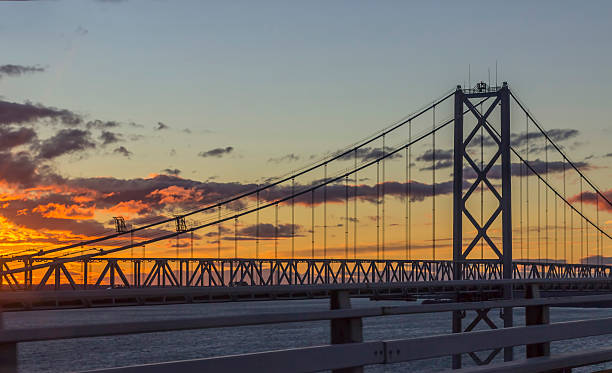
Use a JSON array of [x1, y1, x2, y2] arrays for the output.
[[0, 0, 612, 266]]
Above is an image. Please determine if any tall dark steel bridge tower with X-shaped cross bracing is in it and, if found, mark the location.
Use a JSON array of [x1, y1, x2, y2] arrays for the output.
[[453, 82, 513, 368]]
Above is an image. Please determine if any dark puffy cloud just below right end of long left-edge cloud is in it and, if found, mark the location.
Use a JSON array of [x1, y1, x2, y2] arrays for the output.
[[38, 129, 96, 159]]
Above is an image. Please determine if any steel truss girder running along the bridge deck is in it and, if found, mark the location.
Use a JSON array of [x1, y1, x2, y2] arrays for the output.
[[0, 258, 612, 291]]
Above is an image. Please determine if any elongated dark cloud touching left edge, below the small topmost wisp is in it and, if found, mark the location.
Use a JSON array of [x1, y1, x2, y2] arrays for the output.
[[0, 101, 83, 126]]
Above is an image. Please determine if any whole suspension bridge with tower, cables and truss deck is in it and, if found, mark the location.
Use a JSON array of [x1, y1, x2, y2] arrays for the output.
[[0, 82, 612, 368]]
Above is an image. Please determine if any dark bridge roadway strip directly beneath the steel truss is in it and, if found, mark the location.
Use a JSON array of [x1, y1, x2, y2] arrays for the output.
[[0, 277, 612, 311]]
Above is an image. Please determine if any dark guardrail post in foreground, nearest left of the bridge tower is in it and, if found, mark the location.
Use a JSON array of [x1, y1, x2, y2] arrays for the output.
[[330, 291, 363, 373]]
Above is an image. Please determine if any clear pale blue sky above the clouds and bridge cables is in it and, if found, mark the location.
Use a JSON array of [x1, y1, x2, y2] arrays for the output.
[[0, 0, 612, 179]]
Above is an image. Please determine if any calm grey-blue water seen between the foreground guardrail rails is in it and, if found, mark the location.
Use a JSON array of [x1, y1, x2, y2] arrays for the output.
[[4, 299, 612, 373]]
